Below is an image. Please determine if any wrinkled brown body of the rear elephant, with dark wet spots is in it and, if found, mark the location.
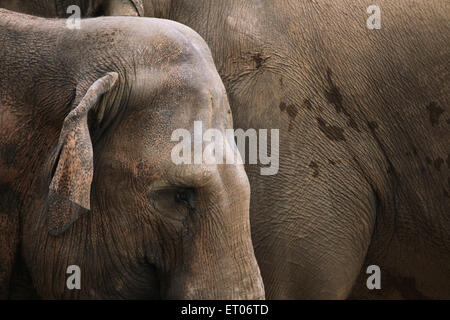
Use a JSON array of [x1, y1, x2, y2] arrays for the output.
[[1, 0, 450, 299]]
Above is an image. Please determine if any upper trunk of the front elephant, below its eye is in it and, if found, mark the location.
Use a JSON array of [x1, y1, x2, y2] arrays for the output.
[[163, 166, 264, 300]]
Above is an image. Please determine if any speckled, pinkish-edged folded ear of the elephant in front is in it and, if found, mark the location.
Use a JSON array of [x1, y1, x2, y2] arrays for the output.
[[47, 72, 118, 236]]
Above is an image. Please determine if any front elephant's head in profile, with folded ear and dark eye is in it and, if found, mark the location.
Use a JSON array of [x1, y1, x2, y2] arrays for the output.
[[0, 9, 264, 299]]
